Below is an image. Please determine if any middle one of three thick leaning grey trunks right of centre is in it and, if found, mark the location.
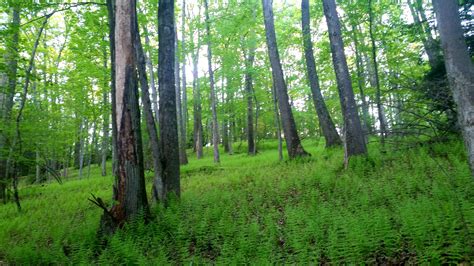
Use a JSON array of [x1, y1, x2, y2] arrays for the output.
[[301, 0, 342, 147]]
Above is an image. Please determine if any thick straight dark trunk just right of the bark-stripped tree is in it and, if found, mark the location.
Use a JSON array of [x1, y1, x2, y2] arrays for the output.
[[159, 0, 180, 203]]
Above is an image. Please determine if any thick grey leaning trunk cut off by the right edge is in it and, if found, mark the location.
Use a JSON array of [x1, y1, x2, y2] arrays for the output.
[[433, 0, 474, 175]]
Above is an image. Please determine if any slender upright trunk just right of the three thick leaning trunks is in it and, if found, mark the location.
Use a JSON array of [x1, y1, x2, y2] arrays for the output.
[[368, 0, 387, 145]]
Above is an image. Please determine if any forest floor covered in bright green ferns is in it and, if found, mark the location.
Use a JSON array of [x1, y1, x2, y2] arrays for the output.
[[0, 140, 474, 265]]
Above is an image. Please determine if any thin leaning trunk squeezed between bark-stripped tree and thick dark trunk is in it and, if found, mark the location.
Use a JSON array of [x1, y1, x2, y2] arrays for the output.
[[135, 7, 163, 201]]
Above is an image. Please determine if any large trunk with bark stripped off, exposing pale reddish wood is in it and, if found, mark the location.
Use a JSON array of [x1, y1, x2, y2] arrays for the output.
[[101, 0, 148, 233]]
